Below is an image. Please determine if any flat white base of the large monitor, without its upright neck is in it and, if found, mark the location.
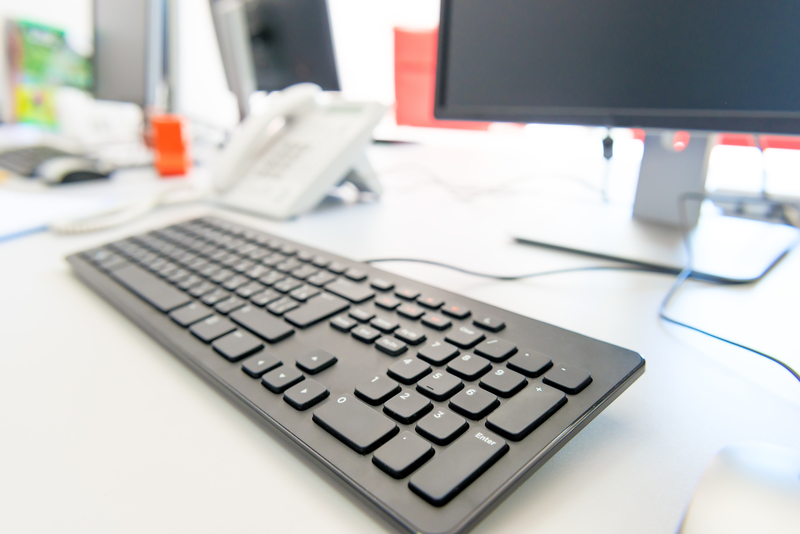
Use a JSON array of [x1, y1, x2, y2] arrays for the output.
[[511, 204, 800, 283]]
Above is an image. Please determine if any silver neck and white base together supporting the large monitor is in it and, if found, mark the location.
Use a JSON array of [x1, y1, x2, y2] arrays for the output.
[[512, 132, 800, 282]]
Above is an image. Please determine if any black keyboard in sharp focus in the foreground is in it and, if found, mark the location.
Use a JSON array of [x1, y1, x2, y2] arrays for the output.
[[68, 217, 645, 533]]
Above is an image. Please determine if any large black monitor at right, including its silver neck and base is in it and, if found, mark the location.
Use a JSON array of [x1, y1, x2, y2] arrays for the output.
[[434, 0, 800, 281]]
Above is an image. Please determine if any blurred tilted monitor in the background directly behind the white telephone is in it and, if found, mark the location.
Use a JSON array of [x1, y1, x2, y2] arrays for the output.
[[211, 0, 339, 117]]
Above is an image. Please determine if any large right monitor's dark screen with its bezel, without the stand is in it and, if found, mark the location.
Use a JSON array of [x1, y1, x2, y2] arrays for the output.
[[436, 0, 800, 133]]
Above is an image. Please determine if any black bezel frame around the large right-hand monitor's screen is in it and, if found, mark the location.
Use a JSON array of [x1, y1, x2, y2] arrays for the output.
[[433, 0, 800, 134]]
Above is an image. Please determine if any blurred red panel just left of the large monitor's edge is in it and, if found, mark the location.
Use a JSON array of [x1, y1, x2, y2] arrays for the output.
[[394, 28, 490, 130]]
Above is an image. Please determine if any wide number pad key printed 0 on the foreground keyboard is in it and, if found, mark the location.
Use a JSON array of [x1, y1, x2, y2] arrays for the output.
[[313, 395, 398, 454]]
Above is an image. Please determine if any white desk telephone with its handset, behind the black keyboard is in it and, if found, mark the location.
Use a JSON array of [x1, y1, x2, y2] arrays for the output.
[[212, 83, 385, 219]]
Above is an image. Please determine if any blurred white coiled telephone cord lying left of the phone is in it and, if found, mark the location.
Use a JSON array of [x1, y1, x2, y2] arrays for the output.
[[49, 187, 211, 234]]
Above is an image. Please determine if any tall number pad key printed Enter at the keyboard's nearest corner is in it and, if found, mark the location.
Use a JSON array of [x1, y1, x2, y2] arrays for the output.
[[408, 427, 508, 506]]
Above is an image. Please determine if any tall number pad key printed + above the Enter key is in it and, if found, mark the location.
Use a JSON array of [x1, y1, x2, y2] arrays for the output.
[[486, 384, 567, 441]]
